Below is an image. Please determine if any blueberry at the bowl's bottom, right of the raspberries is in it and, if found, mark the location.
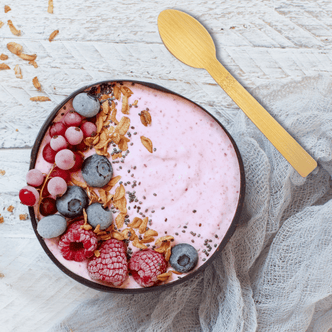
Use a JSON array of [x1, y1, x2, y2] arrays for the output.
[[169, 243, 198, 273]]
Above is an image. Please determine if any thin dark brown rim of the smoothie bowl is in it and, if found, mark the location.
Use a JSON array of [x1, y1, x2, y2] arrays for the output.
[[29, 79, 246, 294]]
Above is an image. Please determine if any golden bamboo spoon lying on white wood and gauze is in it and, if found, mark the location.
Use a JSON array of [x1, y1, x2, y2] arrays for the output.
[[158, 9, 317, 177]]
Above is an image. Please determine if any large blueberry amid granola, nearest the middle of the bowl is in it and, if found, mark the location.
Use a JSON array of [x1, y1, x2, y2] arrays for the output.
[[81, 154, 113, 188]]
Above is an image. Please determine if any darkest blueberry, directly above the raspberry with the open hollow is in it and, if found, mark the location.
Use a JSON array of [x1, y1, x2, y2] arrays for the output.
[[56, 186, 89, 218]]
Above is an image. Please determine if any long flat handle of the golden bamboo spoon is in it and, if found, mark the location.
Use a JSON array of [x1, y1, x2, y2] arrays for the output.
[[205, 58, 317, 177]]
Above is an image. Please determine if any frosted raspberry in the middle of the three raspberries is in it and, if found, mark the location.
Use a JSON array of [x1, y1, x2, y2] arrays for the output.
[[88, 239, 128, 286]]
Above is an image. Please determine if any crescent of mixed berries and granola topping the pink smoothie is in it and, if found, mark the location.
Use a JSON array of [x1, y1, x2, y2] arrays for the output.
[[19, 83, 198, 287]]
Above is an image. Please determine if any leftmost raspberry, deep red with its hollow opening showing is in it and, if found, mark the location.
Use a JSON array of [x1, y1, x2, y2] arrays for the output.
[[59, 220, 98, 262]]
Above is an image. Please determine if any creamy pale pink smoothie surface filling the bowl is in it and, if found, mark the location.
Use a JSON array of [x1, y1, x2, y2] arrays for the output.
[[35, 82, 241, 288]]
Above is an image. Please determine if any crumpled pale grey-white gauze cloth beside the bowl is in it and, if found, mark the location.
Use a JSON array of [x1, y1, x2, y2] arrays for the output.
[[52, 76, 332, 332]]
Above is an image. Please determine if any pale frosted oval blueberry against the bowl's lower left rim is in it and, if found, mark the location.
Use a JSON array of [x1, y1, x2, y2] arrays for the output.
[[37, 214, 67, 239]]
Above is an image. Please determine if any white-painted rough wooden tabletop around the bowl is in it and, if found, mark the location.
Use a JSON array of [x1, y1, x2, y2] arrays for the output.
[[0, 0, 332, 331]]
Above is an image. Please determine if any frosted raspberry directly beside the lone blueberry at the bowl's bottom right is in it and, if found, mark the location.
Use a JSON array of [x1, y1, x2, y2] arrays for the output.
[[129, 249, 167, 287]]
